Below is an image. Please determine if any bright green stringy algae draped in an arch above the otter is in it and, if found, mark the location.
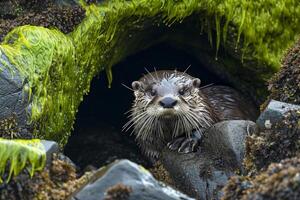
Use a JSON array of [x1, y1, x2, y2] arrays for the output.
[[0, 0, 300, 145]]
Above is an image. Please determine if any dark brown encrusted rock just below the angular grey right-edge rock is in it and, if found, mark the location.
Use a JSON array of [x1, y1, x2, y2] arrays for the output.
[[244, 110, 300, 171]]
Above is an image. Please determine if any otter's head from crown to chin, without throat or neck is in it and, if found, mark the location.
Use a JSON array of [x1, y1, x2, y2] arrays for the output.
[[132, 72, 201, 119]]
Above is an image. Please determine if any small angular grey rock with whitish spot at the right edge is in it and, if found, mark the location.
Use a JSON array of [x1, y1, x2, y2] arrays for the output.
[[256, 100, 300, 129]]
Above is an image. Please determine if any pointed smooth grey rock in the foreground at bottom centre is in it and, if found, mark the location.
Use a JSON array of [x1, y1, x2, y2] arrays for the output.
[[73, 160, 191, 200]]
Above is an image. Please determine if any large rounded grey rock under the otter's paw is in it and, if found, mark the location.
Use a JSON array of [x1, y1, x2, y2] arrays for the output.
[[162, 120, 256, 199]]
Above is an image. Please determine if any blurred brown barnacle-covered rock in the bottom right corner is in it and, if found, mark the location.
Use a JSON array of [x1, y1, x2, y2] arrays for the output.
[[222, 157, 300, 200]]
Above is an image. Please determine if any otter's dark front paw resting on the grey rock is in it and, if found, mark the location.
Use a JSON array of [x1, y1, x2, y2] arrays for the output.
[[167, 131, 203, 153]]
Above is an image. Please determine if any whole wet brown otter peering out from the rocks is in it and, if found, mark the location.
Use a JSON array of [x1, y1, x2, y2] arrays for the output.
[[123, 70, 257, 158]]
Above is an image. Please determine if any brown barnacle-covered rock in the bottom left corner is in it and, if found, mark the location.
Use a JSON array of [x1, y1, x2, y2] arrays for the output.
[[0, 155, 91, 200]]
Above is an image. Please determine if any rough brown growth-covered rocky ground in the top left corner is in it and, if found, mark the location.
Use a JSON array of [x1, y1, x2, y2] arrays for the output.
[[0, 0, 85, 41]]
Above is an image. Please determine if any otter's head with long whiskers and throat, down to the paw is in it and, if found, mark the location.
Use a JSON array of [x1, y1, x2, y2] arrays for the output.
[[124, 71, 213, 146]]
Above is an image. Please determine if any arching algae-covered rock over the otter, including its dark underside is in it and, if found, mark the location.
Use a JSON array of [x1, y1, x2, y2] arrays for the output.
[[0, 0, 300, 146]]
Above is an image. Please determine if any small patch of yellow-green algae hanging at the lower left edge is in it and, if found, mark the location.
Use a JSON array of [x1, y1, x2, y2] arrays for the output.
[[0, 138, 46, 183]]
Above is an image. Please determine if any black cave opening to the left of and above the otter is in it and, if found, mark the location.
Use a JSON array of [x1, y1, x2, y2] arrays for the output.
[[64, 43, 227, 168]]
